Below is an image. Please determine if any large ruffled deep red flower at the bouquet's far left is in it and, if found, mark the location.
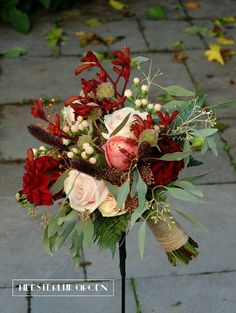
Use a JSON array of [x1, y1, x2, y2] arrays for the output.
[[22, 156, 60, 205]]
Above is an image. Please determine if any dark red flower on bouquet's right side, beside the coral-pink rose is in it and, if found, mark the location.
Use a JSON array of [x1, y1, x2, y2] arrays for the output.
[[150, 136, 184, 186]]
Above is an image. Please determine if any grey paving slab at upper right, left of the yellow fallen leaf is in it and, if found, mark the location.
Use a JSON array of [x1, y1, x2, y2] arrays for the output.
[[142, 21, 204, 51]]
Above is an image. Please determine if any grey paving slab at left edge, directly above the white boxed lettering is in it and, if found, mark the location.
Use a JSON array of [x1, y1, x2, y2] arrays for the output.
[[0, 197, 84, 287]]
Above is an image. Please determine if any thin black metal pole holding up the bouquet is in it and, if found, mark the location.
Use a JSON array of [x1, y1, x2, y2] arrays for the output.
[[119, 233, 126, 313]]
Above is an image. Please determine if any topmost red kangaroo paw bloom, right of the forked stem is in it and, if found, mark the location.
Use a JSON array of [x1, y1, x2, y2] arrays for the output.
[[111, 47, 130, 80]]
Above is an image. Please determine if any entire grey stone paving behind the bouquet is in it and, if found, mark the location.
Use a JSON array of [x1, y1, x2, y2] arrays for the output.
[[0, 0, 236, 313]]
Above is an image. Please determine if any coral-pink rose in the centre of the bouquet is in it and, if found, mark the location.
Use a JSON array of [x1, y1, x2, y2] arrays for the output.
[[103, 136, 138, 170]]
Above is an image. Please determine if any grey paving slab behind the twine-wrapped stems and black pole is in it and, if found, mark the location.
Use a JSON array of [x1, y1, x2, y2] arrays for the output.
[[85, 184, 236, 278]]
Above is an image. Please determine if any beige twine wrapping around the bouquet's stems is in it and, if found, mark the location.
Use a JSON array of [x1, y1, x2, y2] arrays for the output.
[[147, 213, 188, 252]]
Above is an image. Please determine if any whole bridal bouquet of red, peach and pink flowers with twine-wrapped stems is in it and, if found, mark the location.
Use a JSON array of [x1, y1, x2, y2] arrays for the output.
[[16, 47, 217, 266]]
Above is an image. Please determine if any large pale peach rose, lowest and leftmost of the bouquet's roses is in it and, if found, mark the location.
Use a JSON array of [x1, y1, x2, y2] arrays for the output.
[[64, 170, 108, 213]]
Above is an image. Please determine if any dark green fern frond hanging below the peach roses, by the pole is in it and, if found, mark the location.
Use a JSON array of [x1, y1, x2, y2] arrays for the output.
[[94, 213, 130, 255]]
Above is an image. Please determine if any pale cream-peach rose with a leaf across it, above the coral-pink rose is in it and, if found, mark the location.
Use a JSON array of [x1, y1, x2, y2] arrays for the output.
[[102, 107, 148, 139]]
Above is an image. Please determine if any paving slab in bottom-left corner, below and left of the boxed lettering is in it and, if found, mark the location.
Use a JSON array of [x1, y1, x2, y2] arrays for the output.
[[0, 288, 28, 313]]
